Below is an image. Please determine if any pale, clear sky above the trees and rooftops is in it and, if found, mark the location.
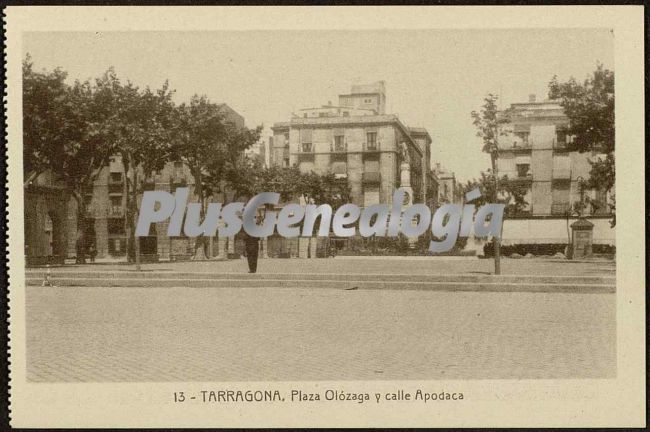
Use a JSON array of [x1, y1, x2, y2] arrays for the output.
[[23, 29, 614, 181]]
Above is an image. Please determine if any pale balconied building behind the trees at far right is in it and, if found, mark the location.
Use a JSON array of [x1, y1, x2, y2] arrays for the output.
[[498, 95, 614, 244]]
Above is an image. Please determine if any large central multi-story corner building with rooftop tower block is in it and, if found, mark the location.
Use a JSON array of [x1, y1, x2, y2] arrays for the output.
[[270, 81, 434, 207]]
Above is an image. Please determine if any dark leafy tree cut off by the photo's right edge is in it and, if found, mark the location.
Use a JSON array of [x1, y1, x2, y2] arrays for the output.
[[549, 63, 616, 226]]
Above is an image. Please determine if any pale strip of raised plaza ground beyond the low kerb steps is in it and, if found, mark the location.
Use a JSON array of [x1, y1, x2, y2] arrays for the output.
[[39, 257, 616, 276]]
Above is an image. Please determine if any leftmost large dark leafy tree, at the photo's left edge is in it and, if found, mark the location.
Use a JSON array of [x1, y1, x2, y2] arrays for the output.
[[23, 56, 113, 258]]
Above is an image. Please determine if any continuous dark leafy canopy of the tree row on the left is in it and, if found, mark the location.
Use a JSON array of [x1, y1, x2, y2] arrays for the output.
[[23, 56, 349, 262]]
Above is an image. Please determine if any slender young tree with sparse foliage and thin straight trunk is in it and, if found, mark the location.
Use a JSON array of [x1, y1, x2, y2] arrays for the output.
[[471, 93, 506, 274]]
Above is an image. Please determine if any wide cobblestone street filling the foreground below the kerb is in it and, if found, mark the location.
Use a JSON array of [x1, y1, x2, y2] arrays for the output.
[[26, 287, 616, 382]]
